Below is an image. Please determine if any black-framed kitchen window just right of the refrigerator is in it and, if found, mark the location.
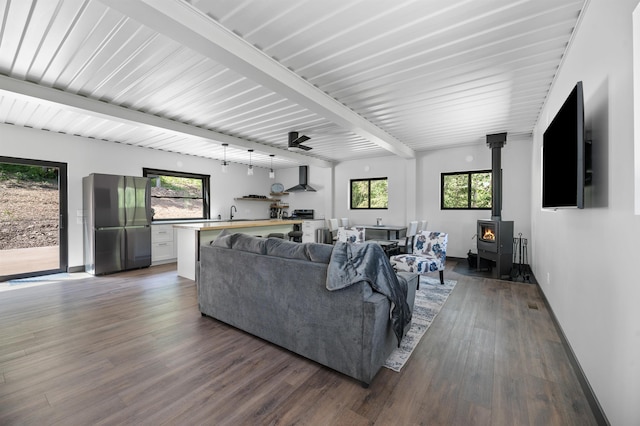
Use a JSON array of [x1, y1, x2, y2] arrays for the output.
[[142, 168, 209, 220]]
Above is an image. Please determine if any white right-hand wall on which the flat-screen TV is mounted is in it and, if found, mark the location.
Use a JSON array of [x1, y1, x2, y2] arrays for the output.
[[531, 0, 640, 425]]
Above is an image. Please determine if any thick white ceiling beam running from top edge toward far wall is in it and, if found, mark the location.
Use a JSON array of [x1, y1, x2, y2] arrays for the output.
[[100, 0, 415, 163]]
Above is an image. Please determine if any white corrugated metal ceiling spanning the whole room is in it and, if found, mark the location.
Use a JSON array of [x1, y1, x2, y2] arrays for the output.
[[0, 0, 584, 167]]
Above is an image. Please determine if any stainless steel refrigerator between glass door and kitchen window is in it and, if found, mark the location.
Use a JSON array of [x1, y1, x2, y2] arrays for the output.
[[82, 173, 151, 275]]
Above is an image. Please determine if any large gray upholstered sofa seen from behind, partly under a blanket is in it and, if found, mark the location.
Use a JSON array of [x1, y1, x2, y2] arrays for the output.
[[198, 234, 418, 386]]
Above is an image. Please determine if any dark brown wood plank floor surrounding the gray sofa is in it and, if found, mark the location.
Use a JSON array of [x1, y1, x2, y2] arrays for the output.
[[0, 264, 596, 426]]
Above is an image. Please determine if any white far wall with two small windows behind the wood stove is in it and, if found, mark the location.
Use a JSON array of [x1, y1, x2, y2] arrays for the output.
[[333, 143, 531, 257]]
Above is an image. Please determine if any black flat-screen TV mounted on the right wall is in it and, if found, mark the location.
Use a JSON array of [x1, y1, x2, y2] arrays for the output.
[[542, 81, 587, 209]]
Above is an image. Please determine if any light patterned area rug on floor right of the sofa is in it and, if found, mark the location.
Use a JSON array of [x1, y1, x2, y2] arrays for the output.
[[384, 275, 457, 371]]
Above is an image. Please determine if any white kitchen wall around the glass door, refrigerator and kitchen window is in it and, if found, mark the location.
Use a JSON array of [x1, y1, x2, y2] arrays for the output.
[[0, 124, 278, 268]]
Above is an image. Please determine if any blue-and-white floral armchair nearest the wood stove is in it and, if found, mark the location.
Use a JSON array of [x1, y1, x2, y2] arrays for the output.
[[389, 231, 449, 284]]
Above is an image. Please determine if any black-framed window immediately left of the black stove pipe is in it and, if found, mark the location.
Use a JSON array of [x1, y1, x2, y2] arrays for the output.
[[440, 170, 491, 210]]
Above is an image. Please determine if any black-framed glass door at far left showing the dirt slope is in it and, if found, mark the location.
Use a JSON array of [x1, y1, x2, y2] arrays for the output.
[[0, 156, 68, 281]]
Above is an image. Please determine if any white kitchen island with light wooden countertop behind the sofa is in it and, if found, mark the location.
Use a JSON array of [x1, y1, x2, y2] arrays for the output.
[[173, 219, 303, 280]]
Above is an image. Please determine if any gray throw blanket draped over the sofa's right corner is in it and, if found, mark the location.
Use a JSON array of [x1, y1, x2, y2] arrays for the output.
[[327, 241, 411, 346]]
